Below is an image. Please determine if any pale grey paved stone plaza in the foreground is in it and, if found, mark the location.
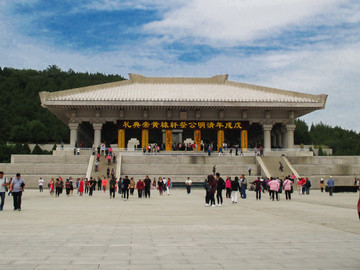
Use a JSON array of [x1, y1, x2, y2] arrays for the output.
[[0, 190, 360, 270]]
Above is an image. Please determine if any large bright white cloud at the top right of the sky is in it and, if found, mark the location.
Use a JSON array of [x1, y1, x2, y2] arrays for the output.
[[144, 0, 359, 47]]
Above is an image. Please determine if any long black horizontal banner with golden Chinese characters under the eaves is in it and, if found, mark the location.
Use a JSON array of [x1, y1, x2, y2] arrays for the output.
[[117, 120, 249, 130]]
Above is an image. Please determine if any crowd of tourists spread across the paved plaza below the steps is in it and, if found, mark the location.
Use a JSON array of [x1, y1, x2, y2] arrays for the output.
[[0, 168, 348, 211]]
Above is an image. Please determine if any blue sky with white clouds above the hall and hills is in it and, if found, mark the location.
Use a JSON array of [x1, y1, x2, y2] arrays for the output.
[[0, 0, 360, 131]]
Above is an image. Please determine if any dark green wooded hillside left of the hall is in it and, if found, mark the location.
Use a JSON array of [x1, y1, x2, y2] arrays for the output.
[[0, 65, 124, 162]]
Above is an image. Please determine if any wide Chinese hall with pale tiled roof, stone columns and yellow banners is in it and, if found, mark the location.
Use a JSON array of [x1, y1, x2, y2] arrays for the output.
[[40, 74, 327, 151]]
